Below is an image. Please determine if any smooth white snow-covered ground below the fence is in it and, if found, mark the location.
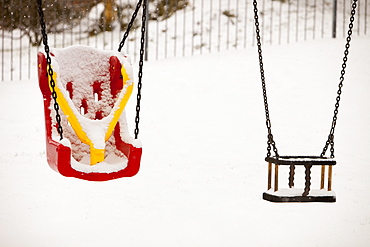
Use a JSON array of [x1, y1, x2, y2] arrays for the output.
[[0, 35, 370, 247]]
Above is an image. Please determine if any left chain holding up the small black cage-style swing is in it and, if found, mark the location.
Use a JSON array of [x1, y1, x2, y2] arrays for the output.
[[253, 0, 279, 157]]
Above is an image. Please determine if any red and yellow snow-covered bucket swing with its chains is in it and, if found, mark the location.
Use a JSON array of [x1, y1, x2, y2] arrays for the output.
[[37, 0, 147, 181]]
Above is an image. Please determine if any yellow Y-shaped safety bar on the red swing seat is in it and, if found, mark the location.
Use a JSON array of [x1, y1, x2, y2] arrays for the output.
[[49, 66, 133, 165]]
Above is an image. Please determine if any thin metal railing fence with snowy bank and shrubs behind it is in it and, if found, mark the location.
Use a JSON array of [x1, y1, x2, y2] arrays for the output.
[[0, 0, 370, 81]]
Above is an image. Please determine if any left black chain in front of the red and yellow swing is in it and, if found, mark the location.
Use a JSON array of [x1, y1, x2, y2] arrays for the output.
[[37, 0, 63, 140]]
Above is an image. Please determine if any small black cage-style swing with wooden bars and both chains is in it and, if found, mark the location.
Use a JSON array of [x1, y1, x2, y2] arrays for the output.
[[253, 0, 357, 202]]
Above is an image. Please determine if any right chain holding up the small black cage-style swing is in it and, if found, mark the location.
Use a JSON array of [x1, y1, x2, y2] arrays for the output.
[[321, 0, 357, 158]]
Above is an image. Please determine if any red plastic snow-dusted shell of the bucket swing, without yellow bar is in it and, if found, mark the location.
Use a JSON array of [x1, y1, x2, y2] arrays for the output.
[[38, 45, 141, 181]]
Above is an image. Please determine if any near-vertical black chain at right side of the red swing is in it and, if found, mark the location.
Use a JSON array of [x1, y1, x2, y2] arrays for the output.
[[132, 0, 148, 139]]
